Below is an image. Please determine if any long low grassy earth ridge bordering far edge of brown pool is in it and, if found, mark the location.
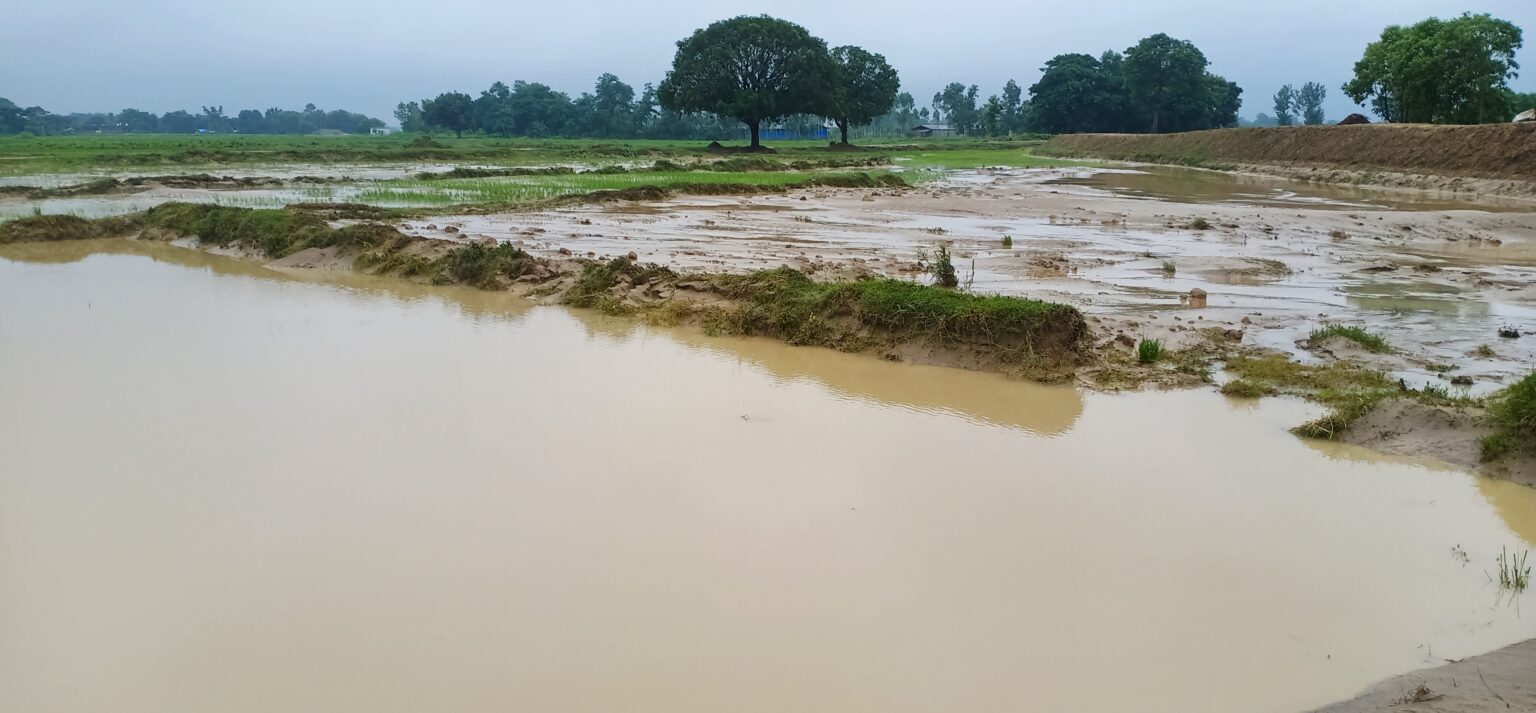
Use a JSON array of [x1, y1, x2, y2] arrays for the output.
[[0, 203, 1087, 380]]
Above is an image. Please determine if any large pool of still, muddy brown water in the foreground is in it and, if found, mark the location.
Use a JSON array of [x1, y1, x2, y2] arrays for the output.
[[0, 241, 1536, 713]]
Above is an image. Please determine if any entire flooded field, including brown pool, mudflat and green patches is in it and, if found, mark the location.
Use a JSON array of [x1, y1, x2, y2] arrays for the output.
[[0, 129, 1536, 713]]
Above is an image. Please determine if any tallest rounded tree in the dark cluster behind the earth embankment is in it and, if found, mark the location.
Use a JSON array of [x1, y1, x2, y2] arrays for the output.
[[1123, 32, 1210, 134]]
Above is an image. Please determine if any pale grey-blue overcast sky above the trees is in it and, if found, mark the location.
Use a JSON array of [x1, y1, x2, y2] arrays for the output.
[[0, 0, 1536, 123]]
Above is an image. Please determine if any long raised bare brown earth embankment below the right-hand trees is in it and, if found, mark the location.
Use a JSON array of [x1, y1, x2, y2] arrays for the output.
[[1035, 123, 1536, 195]]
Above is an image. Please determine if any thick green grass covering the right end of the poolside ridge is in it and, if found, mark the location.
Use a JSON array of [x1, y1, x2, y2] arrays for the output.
[[707, 267, 1087, 355]]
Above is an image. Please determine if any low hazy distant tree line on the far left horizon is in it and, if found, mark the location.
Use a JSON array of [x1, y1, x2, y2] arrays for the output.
[[0, 97, 384, 135]]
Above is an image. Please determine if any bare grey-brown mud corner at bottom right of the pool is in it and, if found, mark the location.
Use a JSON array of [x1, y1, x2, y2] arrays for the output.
[[1313, 639, 1536, 713]]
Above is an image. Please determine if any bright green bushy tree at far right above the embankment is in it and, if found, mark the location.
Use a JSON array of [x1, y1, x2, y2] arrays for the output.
[[1344, 14, 1522, 124]]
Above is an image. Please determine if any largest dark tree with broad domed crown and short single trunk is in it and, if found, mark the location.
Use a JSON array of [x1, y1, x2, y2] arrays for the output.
[[656, 15, 837, 149]]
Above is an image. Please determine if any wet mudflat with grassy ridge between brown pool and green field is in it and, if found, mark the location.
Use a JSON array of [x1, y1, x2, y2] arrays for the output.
[[0, 178, 1531, 485]]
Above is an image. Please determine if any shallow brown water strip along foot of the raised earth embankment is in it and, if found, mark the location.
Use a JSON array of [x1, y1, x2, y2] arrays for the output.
[[1048, 166, 1533, 212]]
